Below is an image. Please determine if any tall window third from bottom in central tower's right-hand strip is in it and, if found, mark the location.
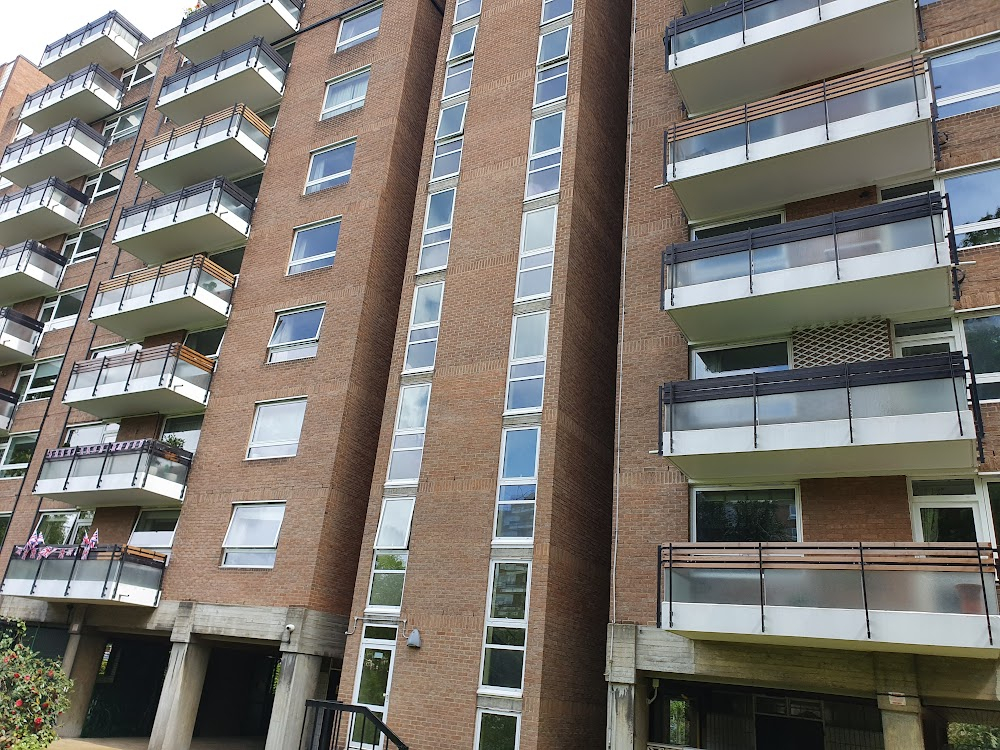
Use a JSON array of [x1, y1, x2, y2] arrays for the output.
[[494, 427, 541, 543]]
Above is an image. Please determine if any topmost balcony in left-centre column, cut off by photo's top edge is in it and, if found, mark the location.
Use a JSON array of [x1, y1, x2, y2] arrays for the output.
[[177, 0, 302, 63]]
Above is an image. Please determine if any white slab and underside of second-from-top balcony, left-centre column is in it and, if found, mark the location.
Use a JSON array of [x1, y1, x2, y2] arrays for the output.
[[156, 68, 281, 125]]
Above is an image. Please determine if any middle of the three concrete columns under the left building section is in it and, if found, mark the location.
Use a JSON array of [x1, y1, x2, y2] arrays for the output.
[[149, 641, 211, 750]]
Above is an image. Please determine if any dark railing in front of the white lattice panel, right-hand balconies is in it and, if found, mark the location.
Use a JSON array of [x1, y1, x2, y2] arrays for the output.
[[659, 352, 985, 463]]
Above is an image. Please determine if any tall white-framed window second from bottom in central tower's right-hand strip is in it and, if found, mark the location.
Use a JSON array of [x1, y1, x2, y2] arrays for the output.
[[482, 562, 531, 694]]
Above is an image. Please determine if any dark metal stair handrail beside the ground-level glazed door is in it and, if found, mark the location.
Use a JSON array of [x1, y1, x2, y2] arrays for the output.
[[301, 700, 409, 750]]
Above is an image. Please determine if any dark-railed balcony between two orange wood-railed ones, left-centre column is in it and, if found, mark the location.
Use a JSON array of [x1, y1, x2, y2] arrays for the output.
[[113, 177, 254, 265]]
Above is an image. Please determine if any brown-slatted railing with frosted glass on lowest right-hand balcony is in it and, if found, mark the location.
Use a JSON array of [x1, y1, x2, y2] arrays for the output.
[[656, 542, 997, 645]]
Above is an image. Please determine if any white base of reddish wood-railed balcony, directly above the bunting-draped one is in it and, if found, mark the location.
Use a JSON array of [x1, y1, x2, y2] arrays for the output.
[[63, 384, 205, 419]]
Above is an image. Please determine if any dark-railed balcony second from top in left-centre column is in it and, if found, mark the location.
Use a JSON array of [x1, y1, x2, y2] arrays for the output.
[[156, 39, 288, 123]]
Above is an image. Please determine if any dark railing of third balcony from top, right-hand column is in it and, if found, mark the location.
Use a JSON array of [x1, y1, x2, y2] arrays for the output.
[[660, 193, 961, 309]]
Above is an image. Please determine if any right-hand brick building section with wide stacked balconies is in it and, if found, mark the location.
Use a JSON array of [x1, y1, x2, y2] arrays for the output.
[[607, 0, 1000, 750]]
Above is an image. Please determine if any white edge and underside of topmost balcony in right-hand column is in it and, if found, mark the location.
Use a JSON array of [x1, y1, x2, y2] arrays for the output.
[[669, 0, 918, 115]]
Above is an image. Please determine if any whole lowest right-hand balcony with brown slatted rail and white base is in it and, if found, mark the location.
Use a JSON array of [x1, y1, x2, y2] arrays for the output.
[[657, 542, 1000, 659]]
